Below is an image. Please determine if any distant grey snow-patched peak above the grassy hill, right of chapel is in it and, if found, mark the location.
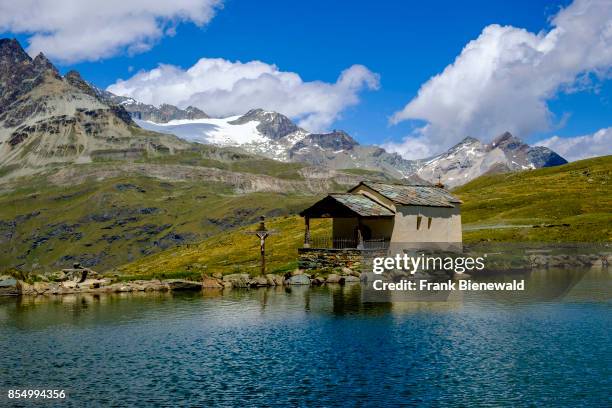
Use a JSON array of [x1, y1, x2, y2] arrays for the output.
[[416, 132, 567, 187]]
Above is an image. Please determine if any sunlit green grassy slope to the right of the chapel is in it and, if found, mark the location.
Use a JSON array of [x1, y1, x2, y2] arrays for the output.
[[453, 156, 612, 242]]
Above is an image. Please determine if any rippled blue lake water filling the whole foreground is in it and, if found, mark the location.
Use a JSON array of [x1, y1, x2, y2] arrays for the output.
[[0, 271, 612, 407]]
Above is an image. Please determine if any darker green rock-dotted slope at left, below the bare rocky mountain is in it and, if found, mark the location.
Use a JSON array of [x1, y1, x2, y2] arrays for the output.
[[0, 177, 313, 271]]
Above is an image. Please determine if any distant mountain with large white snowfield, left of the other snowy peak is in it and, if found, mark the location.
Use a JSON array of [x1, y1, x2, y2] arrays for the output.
[[136, 109, 416, 178]]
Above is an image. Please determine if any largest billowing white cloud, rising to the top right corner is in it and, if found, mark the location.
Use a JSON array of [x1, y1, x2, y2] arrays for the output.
[[391, 0, 612, 158]]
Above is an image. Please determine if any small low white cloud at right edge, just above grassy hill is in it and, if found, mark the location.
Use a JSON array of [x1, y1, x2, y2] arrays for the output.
[[534, 127, 612, 161]]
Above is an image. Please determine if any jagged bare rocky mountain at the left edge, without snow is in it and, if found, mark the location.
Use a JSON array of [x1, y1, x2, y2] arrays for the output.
[[0, 39, 189, 174]]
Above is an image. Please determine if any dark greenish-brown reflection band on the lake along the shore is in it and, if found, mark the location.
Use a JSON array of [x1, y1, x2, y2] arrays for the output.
[[0, 269, 612, 330]]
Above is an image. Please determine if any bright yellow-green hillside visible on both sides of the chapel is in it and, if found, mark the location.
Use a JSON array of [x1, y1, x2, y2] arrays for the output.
[[118, 156, 612, 277]]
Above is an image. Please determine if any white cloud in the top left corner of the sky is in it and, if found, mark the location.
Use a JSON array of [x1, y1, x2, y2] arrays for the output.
[[0, 0, 221, 63]]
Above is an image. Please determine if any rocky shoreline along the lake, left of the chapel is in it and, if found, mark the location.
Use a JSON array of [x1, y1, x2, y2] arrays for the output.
[[0, 268, 361, 296]]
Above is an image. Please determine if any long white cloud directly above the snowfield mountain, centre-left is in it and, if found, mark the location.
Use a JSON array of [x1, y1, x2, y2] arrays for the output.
[[107, 58, 379, 131]]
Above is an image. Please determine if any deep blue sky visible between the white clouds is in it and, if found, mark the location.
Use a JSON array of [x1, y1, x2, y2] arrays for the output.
[[0, 0, 612, 159]]
